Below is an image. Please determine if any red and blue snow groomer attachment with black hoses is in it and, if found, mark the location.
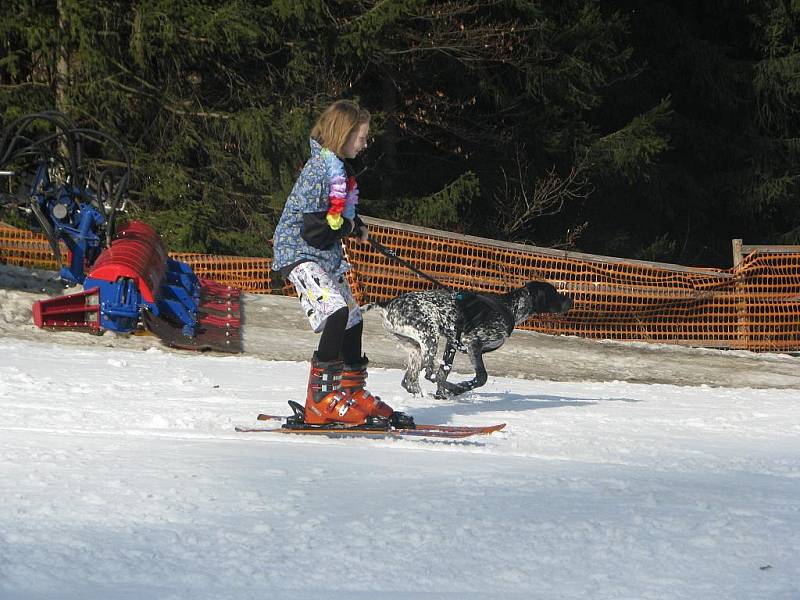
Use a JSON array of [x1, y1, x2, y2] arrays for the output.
[[0, 112, 242, 352]]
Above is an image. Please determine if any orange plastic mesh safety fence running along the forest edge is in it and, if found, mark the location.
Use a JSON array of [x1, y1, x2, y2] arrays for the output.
[[0, 218, 800, 352]]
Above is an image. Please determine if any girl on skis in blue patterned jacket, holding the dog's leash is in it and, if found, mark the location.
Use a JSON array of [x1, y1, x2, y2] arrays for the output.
[[272, 100, 408, 426]]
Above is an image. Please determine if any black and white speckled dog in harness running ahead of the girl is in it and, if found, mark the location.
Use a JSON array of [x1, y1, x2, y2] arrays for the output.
[[369, 281, 572, 398]]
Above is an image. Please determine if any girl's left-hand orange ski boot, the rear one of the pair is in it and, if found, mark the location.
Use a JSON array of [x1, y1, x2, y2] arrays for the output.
[[305, 353, 367, 425]]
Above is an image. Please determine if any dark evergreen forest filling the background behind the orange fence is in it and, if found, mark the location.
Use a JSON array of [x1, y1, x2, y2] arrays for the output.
[[0, 0, 800, 267]]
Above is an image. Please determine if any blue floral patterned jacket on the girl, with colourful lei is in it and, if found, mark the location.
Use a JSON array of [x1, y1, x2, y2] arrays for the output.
[[272, 138, 362, 275]]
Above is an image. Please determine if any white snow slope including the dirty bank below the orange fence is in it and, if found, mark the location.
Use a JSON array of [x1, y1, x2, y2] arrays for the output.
[[0, 267, 800, 600]]
